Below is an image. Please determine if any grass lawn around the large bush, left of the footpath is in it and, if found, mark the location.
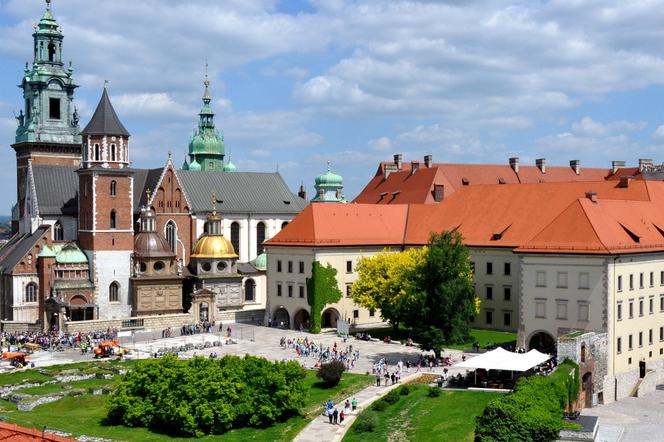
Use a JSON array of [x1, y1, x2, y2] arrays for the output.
[[0, 364, 373, 442]]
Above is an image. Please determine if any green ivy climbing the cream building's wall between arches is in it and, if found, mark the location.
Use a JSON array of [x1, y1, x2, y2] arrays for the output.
[[307, 261, 341, 333]]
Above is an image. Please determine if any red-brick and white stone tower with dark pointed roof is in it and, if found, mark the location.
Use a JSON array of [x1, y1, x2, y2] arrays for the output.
[[78, 87, 134, 319]]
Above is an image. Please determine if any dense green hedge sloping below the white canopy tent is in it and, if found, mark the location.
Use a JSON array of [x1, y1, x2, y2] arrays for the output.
[[475, 360, 579, 442]]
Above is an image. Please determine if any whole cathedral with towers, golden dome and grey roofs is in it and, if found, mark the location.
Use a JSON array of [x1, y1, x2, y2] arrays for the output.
[[0, 3, 307, 329]]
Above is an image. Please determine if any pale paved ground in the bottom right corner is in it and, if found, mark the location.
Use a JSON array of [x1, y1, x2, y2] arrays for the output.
[[583, 390, 664, 442]]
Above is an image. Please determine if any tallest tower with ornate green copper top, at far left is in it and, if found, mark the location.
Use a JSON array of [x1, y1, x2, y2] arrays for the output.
[[12, 0, 81, 220]]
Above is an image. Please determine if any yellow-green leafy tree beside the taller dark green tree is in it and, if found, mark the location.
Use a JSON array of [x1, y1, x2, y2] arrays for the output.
[[350, 247, 427, 330]]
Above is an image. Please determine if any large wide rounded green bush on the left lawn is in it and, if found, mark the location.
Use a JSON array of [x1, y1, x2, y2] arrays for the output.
[[107, 355, 305, 437]]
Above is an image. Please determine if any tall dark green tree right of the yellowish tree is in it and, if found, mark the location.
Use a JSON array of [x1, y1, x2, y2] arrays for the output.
[[416, 231, 479, 355]]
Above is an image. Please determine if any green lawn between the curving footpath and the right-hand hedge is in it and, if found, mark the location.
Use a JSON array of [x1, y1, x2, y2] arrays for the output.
[[344, 385, 499, 442]]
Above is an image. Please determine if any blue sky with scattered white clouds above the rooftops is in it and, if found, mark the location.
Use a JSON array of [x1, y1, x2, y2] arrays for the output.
[[0, 0, 664, 214]]
